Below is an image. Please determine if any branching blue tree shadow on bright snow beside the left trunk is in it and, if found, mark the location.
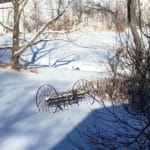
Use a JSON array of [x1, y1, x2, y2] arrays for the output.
[[20, 41, 79, 68]]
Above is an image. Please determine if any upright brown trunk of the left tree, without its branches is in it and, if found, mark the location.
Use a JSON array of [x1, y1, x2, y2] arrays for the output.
[[12, 0, 21, 70]]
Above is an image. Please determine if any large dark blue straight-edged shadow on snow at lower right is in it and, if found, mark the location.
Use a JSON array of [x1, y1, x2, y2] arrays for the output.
[[51, 105, 141, 150]]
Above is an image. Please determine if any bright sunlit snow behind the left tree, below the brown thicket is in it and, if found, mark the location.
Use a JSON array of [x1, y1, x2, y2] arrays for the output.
[[0, 31, 117, 72]]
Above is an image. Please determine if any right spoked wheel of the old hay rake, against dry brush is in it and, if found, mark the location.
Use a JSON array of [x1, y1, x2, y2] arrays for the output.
[[72, 79, 94, 104]]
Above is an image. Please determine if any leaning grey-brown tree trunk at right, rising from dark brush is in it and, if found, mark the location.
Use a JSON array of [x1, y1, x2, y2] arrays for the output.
[[128, 0, 149, 110]]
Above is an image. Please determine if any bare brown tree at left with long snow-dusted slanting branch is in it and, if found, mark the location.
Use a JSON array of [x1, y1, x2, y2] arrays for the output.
[[0, 0, 69, 70]]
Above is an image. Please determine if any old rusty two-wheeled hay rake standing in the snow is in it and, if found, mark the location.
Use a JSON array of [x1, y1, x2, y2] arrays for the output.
[[36, 79, 95, 113]]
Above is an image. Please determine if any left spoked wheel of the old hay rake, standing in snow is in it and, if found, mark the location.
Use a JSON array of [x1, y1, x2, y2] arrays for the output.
[[36, 85, 58, 113]]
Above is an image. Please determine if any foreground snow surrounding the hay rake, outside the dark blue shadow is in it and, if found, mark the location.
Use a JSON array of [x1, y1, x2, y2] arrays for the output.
[[0, 69, 105, 150]]
